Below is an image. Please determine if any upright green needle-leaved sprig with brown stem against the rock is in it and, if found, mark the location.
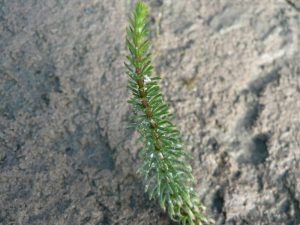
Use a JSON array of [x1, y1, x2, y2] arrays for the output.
[[125, 1, 214, 224]]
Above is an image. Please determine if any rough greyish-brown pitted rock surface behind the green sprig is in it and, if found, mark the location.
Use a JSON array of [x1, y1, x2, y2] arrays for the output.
[[0, 0, 300, 225]]
